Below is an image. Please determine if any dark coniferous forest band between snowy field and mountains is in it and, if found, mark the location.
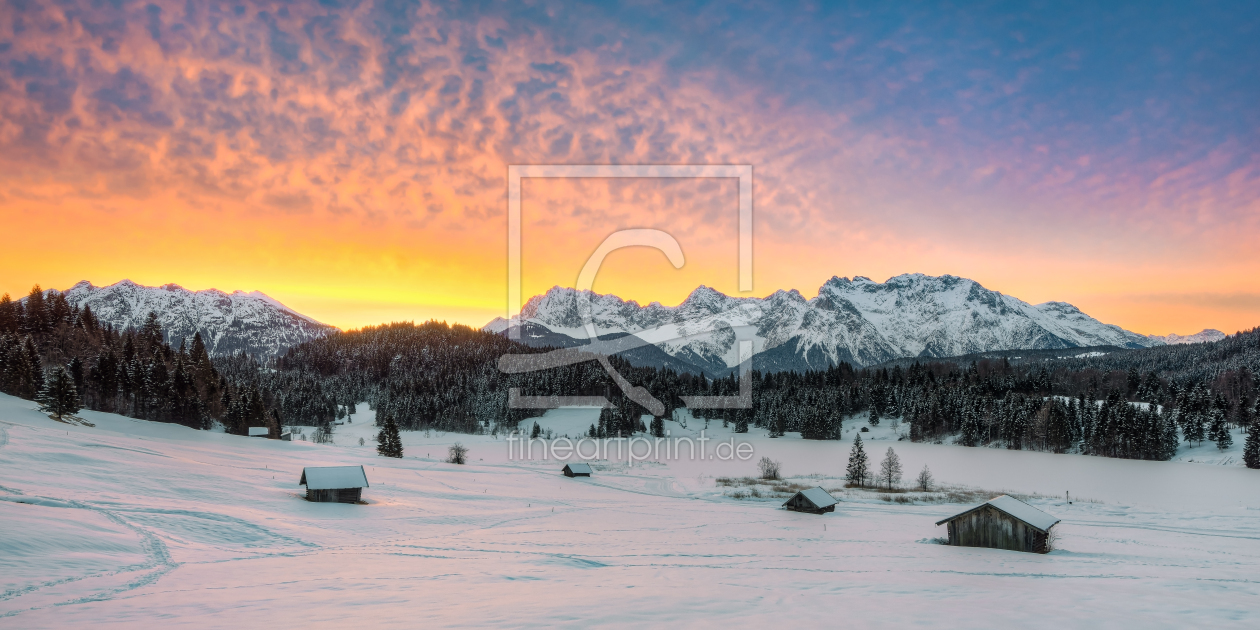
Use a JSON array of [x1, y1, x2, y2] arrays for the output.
[[0, 287, 1260, 465]]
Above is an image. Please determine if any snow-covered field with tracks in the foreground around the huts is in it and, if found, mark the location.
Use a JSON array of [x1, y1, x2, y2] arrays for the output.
[[7, 396, 1260, 629]]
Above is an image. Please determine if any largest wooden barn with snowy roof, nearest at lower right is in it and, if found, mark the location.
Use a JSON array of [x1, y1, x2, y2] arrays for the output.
[[936, 494, 1058, 553]]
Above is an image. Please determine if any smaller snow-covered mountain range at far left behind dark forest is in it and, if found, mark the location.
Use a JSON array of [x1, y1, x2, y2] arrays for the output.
[[45, 280, 336, 355]]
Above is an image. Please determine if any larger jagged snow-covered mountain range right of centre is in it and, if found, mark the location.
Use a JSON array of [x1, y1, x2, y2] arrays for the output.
[[484, 273, 1164, 374]]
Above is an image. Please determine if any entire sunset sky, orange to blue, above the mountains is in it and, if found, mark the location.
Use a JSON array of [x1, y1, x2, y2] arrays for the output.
[[0, 0, 1260, 334]]
